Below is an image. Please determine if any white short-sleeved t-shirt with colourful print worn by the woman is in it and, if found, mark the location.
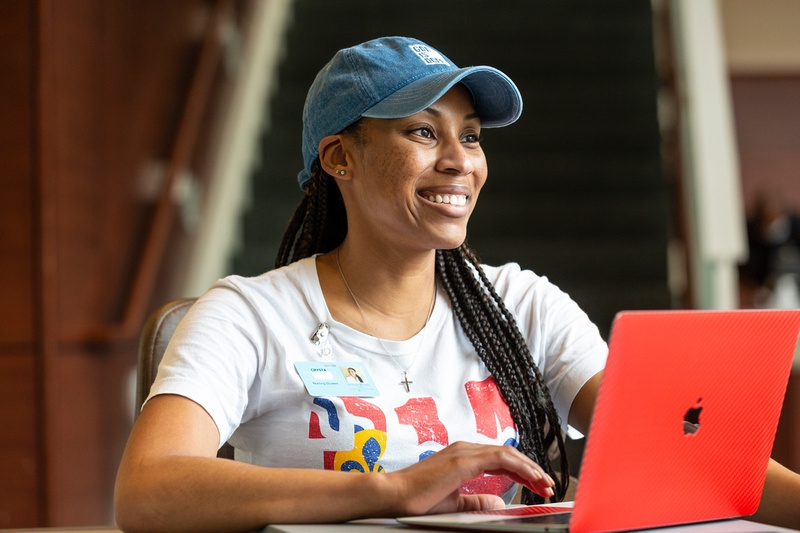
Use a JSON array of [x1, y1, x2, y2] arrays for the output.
[[150, 257, 607, 494]]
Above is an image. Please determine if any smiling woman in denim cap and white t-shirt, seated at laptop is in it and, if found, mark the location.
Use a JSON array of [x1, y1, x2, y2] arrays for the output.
[[116, 37, 607, 531]]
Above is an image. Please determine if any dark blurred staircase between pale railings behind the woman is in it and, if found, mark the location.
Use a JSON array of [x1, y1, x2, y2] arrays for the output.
[[234, 0, 670, 336]]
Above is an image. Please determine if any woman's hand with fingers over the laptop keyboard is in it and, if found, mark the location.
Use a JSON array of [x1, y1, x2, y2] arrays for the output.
[[386, 442, 554, 515]]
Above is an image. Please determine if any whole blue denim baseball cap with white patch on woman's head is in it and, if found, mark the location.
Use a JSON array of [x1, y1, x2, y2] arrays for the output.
[[297, 37, 522, 189]]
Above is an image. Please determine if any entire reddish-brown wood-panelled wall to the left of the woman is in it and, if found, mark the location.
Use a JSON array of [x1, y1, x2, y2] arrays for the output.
[[0, 0, 236, 529]]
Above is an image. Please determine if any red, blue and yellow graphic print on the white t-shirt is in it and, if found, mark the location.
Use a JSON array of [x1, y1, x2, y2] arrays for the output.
[[308, 376, 517, 495]]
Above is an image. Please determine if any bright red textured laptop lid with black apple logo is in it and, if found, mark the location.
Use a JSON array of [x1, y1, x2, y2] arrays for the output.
[[400, 310, 800, 533]]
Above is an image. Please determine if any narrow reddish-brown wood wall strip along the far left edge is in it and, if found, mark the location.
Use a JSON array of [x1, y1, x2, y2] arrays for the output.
[[0, 0, 44, 528]]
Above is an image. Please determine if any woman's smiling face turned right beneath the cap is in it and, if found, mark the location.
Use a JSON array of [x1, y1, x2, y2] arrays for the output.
[[343, 84, 487, 254]]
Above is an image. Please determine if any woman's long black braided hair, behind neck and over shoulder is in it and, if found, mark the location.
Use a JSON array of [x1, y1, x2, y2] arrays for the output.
[[275, 160, 569, 504]]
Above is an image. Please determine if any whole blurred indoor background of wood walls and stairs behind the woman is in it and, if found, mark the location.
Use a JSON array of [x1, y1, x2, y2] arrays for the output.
[[0, 0, 800, 528]]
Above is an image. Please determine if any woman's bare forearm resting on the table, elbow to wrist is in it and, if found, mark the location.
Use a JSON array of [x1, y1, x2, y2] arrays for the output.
[[115, 456, 402, 532]]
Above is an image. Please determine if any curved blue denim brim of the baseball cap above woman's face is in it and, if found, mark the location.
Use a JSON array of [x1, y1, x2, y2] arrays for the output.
[[361, 66, 522, 128]]
